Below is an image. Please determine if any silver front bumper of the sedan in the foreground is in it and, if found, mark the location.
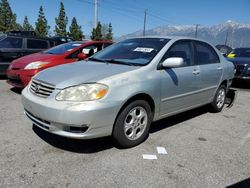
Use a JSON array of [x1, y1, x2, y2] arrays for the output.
[[22, 87, 120, 139]]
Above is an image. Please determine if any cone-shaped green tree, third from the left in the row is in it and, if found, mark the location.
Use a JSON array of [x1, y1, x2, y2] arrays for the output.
[[35, 6, 50, 37]]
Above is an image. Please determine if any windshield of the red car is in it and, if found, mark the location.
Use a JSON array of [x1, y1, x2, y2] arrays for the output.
[[43, 42, 84, 55]]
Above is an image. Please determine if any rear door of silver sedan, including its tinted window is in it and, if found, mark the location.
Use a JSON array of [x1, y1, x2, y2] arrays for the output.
[[195, 41, 223, 103]]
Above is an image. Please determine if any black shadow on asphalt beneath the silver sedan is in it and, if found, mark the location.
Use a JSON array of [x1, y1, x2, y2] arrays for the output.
[[33, 106, 208, 153]]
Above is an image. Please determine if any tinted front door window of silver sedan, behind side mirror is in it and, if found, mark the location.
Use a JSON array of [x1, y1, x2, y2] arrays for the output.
[[162, 41, 193, 66]]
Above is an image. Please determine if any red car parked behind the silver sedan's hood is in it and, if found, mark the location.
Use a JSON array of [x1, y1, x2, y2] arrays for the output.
[[7, 41, 112, 88]]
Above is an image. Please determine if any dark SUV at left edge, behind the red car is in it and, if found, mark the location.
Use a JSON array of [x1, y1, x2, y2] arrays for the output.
[[0, 32, 55, 75]]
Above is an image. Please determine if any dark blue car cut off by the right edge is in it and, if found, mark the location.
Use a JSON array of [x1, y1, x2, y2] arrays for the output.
[[228, 48, 250, 82]]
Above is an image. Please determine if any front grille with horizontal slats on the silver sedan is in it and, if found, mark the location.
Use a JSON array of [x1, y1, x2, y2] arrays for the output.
[[30, 79, 55, 98]]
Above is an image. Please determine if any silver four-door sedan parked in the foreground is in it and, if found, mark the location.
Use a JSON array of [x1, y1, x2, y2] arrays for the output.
[[22, 37, 234, 147]]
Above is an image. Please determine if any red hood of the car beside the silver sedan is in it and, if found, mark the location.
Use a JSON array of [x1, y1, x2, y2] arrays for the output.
[[11, 53, 61, 69]]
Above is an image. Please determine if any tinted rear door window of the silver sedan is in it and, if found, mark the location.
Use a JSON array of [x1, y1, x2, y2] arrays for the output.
[[196, 42, 220, 65]]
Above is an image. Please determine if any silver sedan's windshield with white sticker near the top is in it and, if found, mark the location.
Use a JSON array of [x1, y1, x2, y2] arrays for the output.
[[89, 38, 169, 66]]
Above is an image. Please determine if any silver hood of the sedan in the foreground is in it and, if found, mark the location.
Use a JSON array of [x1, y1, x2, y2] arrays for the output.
[[35, 61, 140, 89]]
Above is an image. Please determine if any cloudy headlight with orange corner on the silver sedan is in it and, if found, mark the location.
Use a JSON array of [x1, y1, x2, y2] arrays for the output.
[[56, 84, 108, 101]]
